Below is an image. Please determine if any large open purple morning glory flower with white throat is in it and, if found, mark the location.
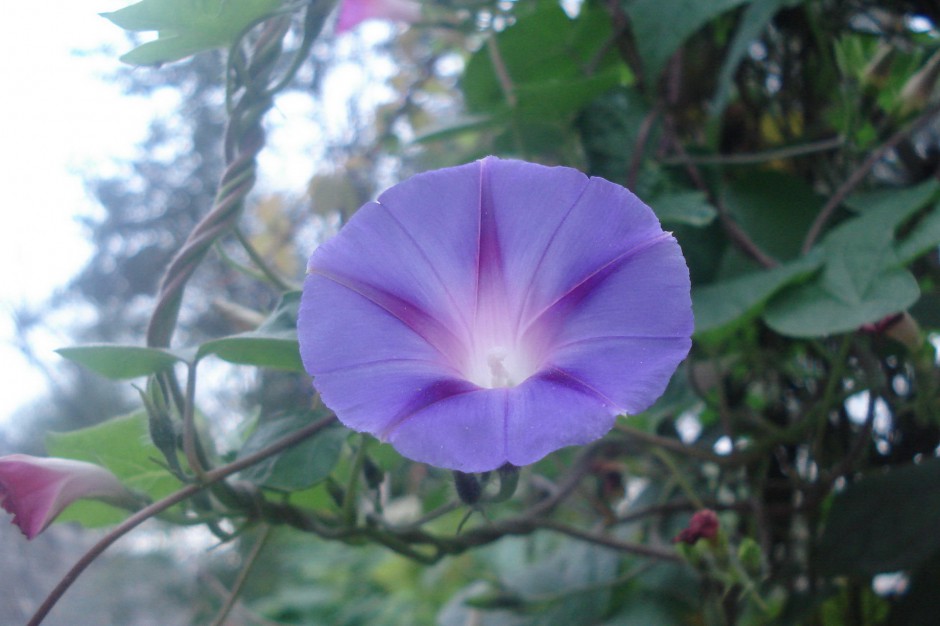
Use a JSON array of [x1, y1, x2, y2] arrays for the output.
[[298, 157, 693, 472]]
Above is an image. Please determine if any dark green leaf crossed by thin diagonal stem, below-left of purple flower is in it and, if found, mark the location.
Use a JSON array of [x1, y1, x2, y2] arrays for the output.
[[238, 412, 349, 491]]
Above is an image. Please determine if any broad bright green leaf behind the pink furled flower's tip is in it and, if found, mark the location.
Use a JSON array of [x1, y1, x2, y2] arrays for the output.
[[46, 411, 181, 527]]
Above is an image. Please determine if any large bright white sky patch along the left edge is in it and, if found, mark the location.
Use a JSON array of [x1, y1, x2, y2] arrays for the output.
[[0, 0, 151, 424]]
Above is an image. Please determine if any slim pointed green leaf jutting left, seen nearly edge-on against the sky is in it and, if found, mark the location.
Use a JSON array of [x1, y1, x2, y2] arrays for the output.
[[56, 344, 184, 380]]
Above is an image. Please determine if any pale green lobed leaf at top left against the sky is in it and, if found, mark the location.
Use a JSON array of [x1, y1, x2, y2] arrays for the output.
[[102, 0, 281, 65]]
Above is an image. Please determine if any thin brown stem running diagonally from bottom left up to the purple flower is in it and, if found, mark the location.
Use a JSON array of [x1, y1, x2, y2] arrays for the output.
[[27, 415, 336, 626]]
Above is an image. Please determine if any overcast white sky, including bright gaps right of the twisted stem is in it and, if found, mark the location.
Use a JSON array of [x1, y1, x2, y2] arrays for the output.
[[0, 0, 394, 425]]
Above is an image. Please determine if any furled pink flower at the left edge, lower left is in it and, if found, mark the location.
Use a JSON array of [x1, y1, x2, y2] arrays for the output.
[[0, 454, 134, 539]]
